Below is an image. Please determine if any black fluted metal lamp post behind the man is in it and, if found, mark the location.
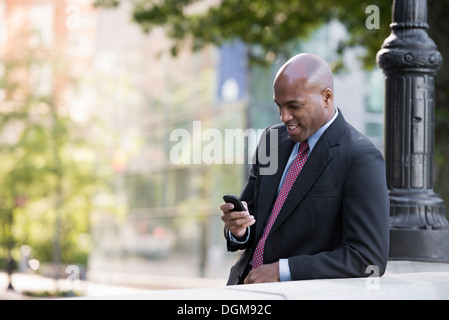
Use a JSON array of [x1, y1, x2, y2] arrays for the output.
[[377, 0, 449, 262]]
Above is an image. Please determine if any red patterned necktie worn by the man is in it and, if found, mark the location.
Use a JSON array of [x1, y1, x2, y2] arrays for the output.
[[251, 140, 309, 269]]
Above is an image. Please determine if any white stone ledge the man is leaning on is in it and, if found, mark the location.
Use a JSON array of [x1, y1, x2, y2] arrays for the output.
[[75, 261, 449, 301]]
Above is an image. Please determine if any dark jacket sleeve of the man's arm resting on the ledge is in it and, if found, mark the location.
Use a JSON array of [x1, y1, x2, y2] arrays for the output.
[[289, 147, 390, 280]]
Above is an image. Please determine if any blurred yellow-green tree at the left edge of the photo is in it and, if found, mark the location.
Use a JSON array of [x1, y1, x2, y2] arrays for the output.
[[0, 51, 115, 270]]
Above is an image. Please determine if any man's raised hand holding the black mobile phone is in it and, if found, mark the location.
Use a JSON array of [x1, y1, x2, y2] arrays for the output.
[[220, 201, 256, 238]]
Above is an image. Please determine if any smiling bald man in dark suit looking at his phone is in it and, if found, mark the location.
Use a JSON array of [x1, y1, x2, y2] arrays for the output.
[[220, 54, 389, 285]]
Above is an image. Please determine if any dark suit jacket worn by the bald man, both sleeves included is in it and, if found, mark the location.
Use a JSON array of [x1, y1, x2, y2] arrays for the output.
[[225, 111, 390, 285]]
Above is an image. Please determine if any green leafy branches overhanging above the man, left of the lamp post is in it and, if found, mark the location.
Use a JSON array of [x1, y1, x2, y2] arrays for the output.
[[96, 0, 391, 66]]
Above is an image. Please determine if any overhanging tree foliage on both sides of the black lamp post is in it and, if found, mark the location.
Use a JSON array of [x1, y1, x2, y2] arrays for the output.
[[96, 0, 449, 215]]
